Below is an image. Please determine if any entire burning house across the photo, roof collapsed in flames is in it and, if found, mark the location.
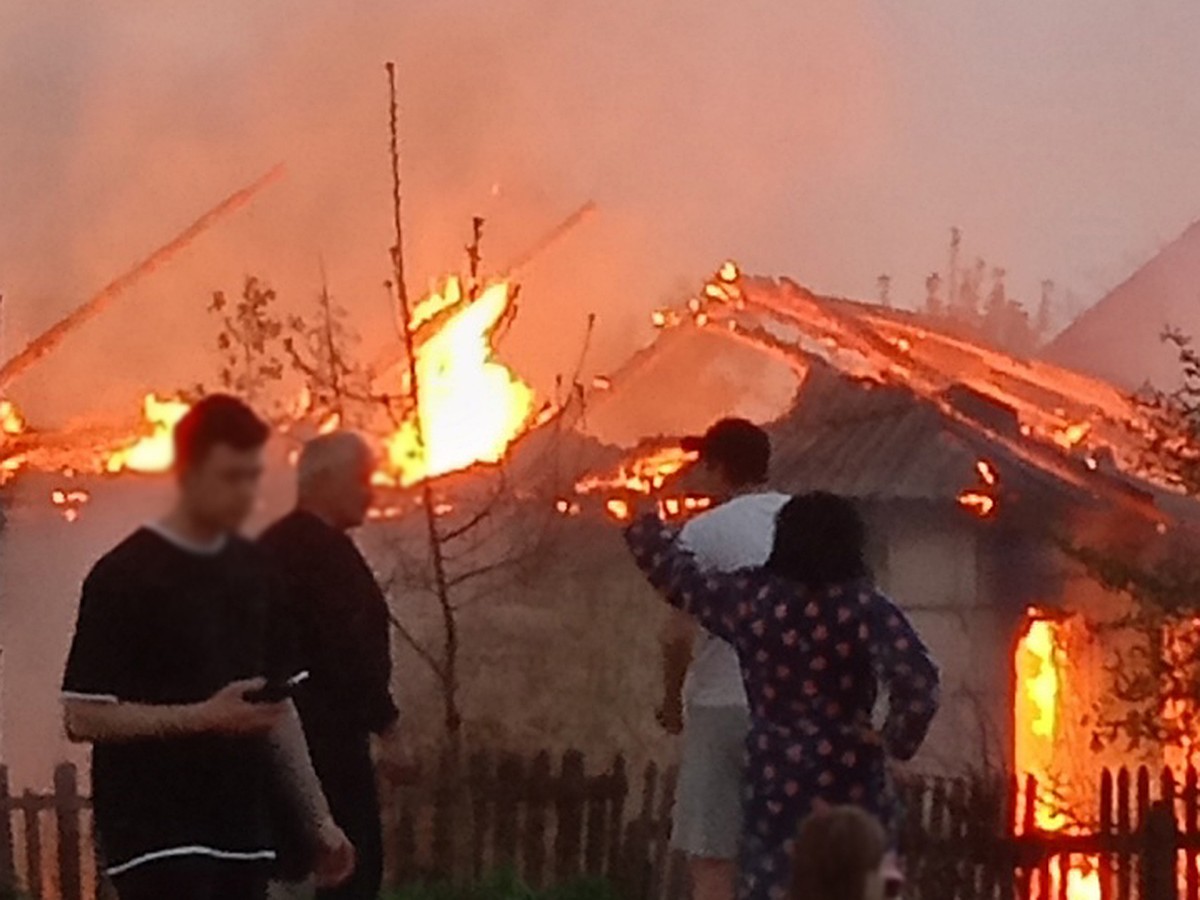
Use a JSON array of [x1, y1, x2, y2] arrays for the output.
[[0, 232, 1200, 900]]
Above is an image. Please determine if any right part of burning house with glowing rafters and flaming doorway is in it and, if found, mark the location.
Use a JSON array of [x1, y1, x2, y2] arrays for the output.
[[566, 269, 1200, 898]]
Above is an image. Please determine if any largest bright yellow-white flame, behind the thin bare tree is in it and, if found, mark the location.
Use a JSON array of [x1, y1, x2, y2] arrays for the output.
[[385, 277, 534, 485]]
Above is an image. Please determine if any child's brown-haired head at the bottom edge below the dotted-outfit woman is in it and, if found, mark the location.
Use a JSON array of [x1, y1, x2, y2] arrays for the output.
[[792, 806, 888, 900]]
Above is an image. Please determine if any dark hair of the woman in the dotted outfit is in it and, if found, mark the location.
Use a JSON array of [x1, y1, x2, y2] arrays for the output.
[[767, 492, 869, 588]]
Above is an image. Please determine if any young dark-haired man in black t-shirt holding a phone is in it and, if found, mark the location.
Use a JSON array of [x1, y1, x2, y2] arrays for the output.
[[62, 396, 354, 900]]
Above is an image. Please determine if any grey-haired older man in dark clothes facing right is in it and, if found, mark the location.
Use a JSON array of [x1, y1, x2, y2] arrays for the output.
[[259, 432, 412, 900]]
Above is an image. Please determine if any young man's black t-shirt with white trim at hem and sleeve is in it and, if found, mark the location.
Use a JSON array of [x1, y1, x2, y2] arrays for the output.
[[62, 528, 296, 875]]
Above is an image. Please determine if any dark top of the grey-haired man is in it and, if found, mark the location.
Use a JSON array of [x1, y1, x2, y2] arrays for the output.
[[259, 510, 398, 748]]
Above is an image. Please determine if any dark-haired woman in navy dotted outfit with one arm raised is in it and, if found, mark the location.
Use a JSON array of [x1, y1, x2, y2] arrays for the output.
[[626, 493, 938, 900]]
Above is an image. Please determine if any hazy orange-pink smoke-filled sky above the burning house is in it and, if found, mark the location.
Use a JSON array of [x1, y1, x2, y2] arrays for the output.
[[0, 0, 1200, 418]]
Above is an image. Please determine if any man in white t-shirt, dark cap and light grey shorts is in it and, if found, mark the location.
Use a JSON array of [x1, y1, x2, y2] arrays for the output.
[[659, 419, 790, 900]]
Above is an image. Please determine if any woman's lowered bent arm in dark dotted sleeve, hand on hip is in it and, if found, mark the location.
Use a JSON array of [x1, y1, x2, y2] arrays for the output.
[[868, 594, 940, 762]]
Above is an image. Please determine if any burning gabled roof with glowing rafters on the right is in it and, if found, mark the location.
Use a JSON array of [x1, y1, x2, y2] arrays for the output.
[[580, 275, 1196, 524]]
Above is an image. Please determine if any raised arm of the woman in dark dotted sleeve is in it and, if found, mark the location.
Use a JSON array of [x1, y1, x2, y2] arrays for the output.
[[625, 516, 752, 644]]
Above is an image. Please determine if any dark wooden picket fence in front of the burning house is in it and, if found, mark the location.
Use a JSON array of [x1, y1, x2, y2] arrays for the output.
[[11, 752, 1200, 900]]
